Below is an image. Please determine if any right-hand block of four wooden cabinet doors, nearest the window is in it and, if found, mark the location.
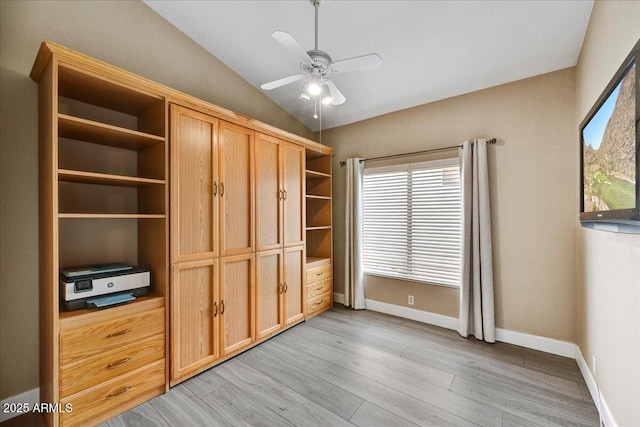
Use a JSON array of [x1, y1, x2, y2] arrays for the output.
[[256, 134, 304, 338]]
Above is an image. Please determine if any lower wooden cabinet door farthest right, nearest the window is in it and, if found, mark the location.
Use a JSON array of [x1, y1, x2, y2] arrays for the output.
[[284, 246, 305, 325]]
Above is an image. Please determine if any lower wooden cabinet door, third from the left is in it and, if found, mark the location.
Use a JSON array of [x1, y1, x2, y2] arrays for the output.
[[256, 249, 284, 339]]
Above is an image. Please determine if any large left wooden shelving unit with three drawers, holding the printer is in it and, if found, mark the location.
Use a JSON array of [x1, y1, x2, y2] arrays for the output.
[[31, 42, 169, 426]]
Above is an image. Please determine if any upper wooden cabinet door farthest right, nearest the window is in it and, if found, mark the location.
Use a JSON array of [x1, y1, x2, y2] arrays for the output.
[[283, 143, 305, 246]]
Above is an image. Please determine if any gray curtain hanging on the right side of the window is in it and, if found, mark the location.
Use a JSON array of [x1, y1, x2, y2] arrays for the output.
[[458, 139, 496, 342]]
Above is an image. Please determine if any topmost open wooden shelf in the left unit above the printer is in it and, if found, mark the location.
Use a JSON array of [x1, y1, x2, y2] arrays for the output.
[[58, 114, 165, 150]]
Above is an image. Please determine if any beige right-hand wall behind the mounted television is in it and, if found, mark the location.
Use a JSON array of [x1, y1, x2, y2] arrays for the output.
[[575, 1, 640, 426]]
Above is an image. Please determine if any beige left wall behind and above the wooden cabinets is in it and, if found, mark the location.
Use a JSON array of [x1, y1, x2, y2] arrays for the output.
[[0, 0, 313, 400]]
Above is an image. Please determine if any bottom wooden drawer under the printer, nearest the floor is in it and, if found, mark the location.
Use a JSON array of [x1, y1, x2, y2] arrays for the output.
[[61, 359, 165, 427]]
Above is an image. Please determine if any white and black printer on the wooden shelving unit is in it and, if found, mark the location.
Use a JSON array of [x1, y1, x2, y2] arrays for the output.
[[60, 264, 151, 311]]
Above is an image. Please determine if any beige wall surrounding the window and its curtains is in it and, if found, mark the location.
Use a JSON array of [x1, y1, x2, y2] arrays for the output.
[[323, 68, 578, 342]]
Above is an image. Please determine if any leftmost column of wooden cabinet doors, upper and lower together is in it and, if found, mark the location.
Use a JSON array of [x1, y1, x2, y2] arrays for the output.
[[170, 105, 220, 383]]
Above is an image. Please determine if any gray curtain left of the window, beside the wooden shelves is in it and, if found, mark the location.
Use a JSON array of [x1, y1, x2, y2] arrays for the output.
[[344, 158, 365, 309]]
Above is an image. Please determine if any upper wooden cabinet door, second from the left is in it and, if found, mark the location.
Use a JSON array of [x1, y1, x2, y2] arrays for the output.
[[219, 121, 255, 256]]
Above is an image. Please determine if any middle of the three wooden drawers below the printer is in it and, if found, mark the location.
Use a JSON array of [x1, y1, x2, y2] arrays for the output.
[[60, 334, 165, 397]]
